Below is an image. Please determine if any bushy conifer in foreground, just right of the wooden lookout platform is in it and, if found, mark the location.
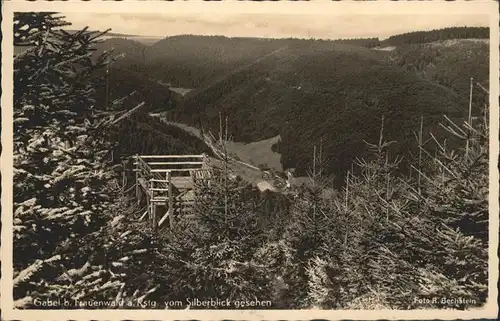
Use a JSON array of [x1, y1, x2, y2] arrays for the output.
[[158, 165, 268, 308]]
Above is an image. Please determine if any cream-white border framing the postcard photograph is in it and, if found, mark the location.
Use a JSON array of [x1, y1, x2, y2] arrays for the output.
[[1, 0, 500, 320]]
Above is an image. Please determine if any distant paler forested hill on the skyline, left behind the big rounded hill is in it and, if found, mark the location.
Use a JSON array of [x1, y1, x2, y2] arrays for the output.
[[97, 35, 386, 88]]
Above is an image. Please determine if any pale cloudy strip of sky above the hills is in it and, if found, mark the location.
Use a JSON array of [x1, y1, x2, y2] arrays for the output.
[[62, 12, 489, 39]]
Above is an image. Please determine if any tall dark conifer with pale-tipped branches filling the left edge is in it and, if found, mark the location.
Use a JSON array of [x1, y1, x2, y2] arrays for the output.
[[13, 12, 157, 308]]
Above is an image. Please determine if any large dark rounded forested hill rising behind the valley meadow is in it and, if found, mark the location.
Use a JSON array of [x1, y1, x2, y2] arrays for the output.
[[171, 45, 467, 183]]
